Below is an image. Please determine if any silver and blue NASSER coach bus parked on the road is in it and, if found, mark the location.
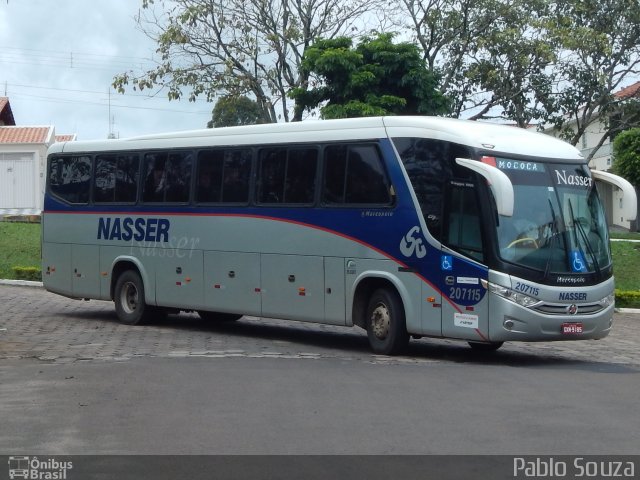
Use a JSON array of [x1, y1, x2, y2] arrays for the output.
[[42, 117, 636, 354]]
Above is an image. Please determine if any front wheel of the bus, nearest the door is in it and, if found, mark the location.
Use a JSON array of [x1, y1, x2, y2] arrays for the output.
[[365, 288, 409, 355]]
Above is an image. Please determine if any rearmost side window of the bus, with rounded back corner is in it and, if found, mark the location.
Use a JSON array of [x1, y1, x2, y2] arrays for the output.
[[49, 156, 91, 203]]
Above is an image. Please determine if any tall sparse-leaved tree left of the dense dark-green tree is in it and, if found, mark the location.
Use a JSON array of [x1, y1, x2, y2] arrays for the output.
[[113, 0, 382, 122]]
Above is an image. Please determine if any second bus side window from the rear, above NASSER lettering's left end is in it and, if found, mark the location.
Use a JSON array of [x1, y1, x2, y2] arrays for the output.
[[93, 154, 139, 203]]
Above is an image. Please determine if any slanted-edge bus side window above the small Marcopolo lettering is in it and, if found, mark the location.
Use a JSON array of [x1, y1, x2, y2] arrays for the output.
[[322, 145, 392, 205]]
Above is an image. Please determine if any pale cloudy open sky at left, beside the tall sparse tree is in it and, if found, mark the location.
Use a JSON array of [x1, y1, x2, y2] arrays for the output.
[[0, 0, 213, 140]]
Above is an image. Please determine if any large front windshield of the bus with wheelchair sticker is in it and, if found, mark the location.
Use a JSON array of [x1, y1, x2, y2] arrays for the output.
[[495, 158, 611, 273]]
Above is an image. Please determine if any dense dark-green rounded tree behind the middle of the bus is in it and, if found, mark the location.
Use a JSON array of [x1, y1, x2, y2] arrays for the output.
[[290, 34, 448, 118]]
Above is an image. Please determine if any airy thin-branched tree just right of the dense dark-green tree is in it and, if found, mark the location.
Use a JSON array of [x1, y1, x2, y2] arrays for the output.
[[393, 0, 555, 126]]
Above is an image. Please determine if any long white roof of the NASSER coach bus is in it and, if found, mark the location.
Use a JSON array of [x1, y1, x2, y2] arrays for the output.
[[49, 116, 584, 162]]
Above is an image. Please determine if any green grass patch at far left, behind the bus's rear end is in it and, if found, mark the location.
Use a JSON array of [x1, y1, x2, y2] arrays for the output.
[[0, 222, 41, 279]]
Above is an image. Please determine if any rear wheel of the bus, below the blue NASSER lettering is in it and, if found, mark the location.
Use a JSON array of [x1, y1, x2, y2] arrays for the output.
[[113, 270, 155, 325]]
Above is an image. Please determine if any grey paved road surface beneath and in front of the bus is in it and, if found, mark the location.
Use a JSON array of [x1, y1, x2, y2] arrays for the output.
[[0, 286, 640, 455]]
